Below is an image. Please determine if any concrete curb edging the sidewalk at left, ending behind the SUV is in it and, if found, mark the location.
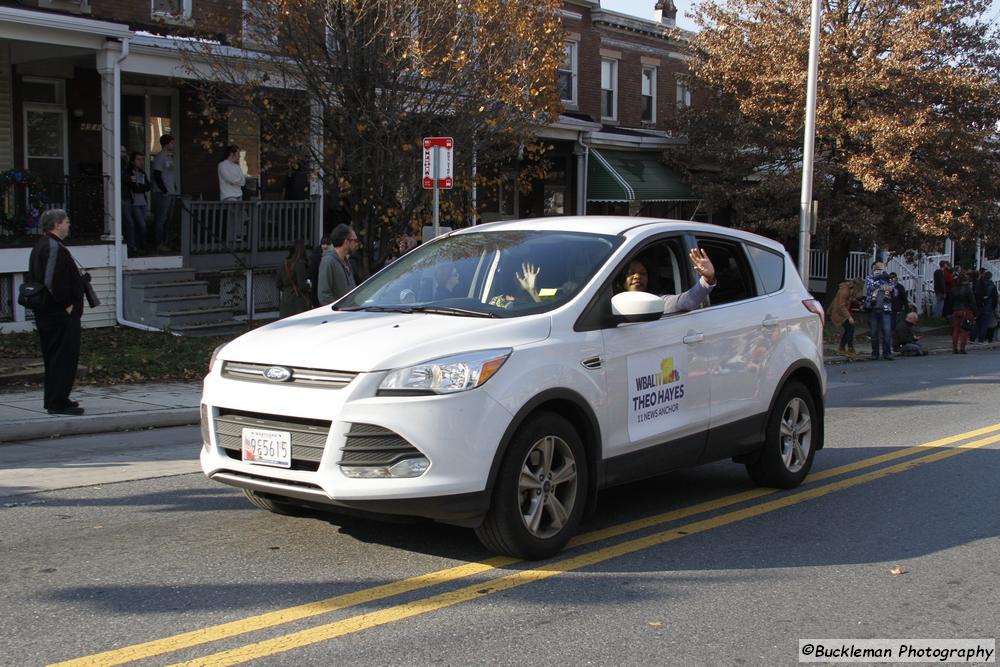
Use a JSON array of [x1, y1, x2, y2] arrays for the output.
[[0, 408, 201, 444]]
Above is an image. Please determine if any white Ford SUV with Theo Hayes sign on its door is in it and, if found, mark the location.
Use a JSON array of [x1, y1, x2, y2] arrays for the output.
[[201, 217, 826, 558]]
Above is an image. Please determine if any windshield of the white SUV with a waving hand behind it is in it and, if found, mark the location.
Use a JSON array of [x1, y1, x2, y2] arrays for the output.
[[336, 230, 621, 317]]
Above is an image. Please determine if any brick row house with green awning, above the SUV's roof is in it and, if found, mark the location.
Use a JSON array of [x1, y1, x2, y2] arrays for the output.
[[482, 0, 698, 221]]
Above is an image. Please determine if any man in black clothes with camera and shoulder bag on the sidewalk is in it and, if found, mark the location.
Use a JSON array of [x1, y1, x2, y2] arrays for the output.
[[27, 209, 84, 415]]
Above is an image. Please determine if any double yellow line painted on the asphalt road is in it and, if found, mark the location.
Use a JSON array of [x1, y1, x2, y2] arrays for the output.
[[57, 424, 1000, 667]]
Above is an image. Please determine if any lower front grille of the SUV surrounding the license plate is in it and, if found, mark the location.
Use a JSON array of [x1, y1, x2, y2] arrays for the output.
[[215, 408, 330, 471]]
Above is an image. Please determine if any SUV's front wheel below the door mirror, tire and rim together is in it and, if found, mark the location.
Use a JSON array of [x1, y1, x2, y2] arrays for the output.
[[476, 413, 588, 560]]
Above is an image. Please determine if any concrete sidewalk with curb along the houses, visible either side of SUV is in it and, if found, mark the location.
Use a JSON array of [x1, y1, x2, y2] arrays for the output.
[[0, 327, 1000, 443]]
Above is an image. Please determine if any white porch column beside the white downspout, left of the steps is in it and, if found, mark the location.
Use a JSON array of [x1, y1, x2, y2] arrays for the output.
[[97, 40, 122, 241]]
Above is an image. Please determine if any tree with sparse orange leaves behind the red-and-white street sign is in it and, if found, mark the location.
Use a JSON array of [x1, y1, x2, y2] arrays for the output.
[[185, 0, 562, 268]]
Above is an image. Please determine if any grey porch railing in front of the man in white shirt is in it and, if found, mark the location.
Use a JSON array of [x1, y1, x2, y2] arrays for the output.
[[181, 199, 321, 266]]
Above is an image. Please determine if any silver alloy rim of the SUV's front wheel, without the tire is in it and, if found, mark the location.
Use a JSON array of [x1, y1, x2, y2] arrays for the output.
[[517, 435, 577, 539]]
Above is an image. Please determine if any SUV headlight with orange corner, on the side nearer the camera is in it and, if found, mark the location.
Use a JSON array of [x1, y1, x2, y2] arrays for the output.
[[378, 348, 512, 396]]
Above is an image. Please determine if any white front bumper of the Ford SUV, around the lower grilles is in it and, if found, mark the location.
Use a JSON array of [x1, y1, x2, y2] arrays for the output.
[[201, 369, 512, 525]]
